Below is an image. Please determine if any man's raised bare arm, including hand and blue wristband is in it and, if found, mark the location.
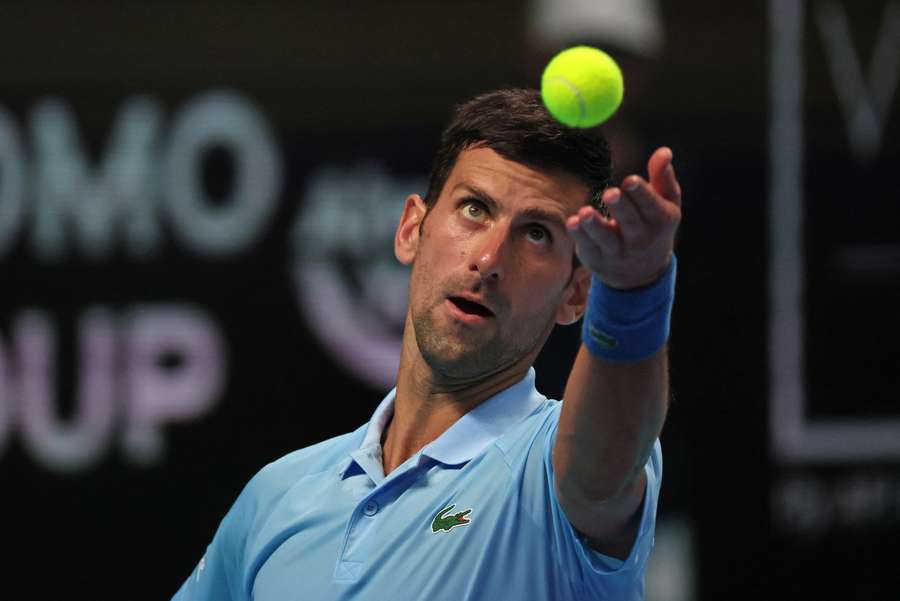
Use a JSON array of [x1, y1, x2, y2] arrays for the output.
[[553, 148, 681, 559]]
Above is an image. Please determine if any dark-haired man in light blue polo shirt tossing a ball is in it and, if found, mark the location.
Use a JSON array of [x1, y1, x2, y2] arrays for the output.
[[175, 90, 681, 600]]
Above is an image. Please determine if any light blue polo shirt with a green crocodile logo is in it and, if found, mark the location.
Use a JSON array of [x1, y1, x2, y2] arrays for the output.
[[174, 369, 662, 601]]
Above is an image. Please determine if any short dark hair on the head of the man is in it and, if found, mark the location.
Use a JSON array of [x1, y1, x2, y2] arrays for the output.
[[425, 88, 612, 210]]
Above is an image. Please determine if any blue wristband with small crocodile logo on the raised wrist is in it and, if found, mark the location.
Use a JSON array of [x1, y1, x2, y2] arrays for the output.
[[581, 254, 677, 362]]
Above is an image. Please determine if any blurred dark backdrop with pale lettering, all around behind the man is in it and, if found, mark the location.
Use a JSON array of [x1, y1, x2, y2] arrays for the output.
[[0, 0, 900, 601]]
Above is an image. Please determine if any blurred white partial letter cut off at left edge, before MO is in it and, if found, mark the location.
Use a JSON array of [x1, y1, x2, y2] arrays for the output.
[[0, 107, 26, 256]]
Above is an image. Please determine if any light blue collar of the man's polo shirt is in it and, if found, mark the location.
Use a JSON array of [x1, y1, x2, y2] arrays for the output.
[[352, 367, 544, 474]]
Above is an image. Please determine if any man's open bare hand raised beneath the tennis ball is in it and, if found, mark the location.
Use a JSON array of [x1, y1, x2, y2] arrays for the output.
[[566, 147, 681, 290]]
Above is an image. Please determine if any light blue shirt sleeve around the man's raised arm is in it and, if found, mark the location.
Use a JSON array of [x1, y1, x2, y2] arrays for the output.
[[535, 410, 662, 600]]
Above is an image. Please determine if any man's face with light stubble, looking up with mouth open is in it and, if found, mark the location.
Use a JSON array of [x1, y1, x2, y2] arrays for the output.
[[395, 147, 590, 378]]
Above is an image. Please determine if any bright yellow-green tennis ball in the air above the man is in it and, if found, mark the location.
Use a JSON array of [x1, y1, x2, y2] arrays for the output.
[[541, 46, 625, 127]]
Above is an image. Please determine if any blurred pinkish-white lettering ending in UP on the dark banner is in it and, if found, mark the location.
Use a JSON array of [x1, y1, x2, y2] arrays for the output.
[[0, 305, 226, 472]]
